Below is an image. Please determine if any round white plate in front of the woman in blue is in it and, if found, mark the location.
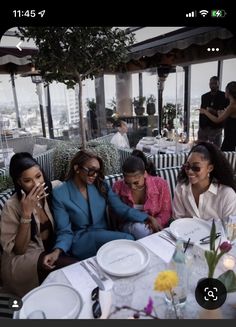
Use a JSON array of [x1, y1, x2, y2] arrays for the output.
[[97, 240, 149, 277]]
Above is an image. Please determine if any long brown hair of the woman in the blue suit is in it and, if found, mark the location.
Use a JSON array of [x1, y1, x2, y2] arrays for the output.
[[65, 150, 107, 198]]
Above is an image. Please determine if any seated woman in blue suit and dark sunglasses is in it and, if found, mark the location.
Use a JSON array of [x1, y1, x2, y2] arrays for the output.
[[45, 150, 157, 265]]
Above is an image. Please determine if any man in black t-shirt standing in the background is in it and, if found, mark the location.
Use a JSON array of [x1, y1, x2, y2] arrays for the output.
[[198, 76, 229, 148]]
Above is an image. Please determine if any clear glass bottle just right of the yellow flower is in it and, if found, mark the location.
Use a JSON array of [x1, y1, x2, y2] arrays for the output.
[[166, 239, 188, 307]]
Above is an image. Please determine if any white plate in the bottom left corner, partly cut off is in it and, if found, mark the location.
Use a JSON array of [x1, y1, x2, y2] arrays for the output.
[[15, 283, 83, 319]]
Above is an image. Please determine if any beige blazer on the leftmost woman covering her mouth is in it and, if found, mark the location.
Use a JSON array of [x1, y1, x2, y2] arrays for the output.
[[0, 183, 60, 296]]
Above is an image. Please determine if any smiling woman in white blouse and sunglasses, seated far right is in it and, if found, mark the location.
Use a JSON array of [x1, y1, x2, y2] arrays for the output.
[[173, 142, 236, 220]]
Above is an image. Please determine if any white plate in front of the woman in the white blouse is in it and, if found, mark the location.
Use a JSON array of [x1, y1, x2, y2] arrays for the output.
[[170, 218, 211, 244]]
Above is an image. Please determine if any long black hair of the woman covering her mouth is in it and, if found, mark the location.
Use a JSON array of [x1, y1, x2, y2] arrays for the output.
[[9, 152, 52, 241]]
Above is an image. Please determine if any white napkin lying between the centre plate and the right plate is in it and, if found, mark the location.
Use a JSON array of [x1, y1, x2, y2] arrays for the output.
[[138, 232, 175, 263]]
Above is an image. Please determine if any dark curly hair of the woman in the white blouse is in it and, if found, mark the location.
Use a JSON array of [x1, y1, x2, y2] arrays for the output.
[[178, 142, 236, 192]]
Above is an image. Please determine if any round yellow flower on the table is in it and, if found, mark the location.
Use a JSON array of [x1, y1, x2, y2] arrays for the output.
[[154, 270, 179, 292]]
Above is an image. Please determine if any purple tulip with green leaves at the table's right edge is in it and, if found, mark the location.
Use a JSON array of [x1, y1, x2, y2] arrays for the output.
[[204, 220, 236, 292]]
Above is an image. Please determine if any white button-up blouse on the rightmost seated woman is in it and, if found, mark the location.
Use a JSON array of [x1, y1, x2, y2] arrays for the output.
[[172, 183, 236, 220]]
